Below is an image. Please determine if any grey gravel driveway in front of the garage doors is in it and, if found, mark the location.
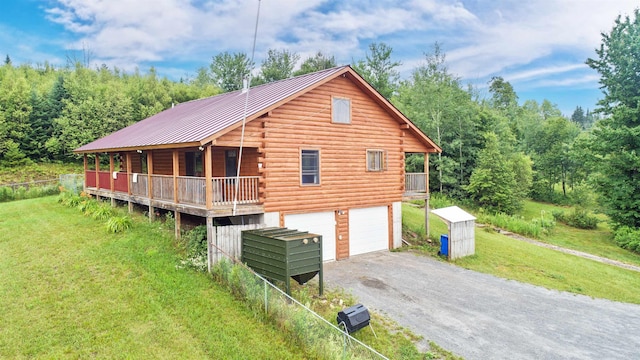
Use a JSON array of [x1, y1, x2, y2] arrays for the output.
[[324, 251, 640, 359]]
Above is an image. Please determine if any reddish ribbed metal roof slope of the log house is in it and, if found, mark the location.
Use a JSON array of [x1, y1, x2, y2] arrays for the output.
[[74, 66, 350, 152]]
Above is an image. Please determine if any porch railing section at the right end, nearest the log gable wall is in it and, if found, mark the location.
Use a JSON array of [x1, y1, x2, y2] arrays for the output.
[[212, 176, 260, 206]]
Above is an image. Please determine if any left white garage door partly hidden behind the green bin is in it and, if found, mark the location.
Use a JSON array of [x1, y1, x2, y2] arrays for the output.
[[284, 211, 336, 261]]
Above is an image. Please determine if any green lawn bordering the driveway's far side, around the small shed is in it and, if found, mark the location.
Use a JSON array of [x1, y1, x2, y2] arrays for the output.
[[403, 204, 640, 304]]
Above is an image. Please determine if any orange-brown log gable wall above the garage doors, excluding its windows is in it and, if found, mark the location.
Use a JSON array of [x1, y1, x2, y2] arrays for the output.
[[252, 77, 428, 213]]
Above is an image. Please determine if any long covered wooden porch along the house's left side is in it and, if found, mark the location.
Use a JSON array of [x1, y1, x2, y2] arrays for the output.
[[84, 145, 264, 218]]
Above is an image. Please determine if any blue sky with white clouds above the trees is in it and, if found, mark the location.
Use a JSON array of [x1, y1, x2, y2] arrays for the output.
[[0, 0, 640, 115]]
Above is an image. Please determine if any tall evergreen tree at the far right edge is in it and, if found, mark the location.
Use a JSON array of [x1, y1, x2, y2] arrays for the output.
[[587, 9, 640, 227]]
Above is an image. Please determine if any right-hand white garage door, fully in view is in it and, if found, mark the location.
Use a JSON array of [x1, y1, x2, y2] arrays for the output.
[[349, 206, 389, 256]]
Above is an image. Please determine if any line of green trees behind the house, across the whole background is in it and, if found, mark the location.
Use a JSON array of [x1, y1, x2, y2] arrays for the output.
[[0, 7, 640, 239]]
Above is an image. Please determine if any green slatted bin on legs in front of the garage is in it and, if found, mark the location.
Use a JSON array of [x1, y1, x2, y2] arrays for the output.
[[242, 227, 323, 295]]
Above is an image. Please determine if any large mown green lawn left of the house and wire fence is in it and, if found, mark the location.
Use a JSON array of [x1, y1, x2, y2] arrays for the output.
[[0, 197, 305, 359]]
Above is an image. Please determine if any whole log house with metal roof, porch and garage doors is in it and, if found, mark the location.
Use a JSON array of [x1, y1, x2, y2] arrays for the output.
[[75, 66, 441, 261]]
